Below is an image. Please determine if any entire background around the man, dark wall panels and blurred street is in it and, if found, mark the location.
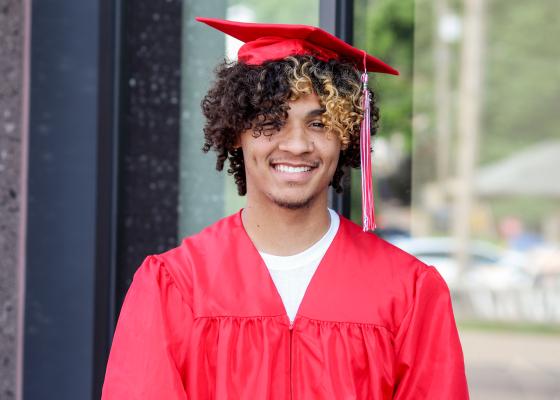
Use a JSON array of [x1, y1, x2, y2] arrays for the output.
[[0, 0, 560, 400]]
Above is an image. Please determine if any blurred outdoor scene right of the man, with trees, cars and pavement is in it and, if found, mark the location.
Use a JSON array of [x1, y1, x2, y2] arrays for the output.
[[352, 0, 560, 399]]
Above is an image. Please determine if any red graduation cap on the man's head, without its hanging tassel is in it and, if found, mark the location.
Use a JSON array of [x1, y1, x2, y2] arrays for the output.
[[196, 17, 399, 75]]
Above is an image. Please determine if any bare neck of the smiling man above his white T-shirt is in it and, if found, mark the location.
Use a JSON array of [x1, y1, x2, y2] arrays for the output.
[[241, 198, 330, 256]]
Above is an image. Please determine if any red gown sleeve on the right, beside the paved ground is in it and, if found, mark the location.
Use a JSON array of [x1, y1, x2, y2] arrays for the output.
[[393, 267, 469, 400]]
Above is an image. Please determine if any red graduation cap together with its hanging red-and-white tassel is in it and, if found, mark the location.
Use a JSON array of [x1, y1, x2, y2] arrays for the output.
[[196, 17, 399, 231]]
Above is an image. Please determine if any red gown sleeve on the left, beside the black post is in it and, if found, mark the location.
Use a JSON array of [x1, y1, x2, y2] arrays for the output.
[[101, 256, 193, 400]]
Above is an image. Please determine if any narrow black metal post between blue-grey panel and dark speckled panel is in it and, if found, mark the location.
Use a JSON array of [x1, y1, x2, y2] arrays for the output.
[[92, 0, 122, 399]]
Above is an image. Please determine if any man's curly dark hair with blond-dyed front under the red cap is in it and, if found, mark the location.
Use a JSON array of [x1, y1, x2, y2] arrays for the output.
[[202, 56, 379, 196]]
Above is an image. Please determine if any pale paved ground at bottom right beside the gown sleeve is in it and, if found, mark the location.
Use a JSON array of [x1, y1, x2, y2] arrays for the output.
[[460, 329, 560, 400]]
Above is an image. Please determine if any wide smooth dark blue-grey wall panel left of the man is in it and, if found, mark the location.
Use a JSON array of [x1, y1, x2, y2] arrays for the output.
[[24, 0, 99, 400]]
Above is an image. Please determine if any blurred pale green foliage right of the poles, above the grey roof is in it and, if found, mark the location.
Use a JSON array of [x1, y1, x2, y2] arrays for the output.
[[480, 0, 560, 163]]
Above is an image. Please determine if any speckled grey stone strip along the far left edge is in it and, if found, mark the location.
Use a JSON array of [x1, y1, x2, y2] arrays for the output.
[[0, 0, 26, 400]]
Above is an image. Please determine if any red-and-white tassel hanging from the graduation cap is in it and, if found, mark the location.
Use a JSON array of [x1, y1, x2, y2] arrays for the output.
[[360, 59, 376, 232]]
